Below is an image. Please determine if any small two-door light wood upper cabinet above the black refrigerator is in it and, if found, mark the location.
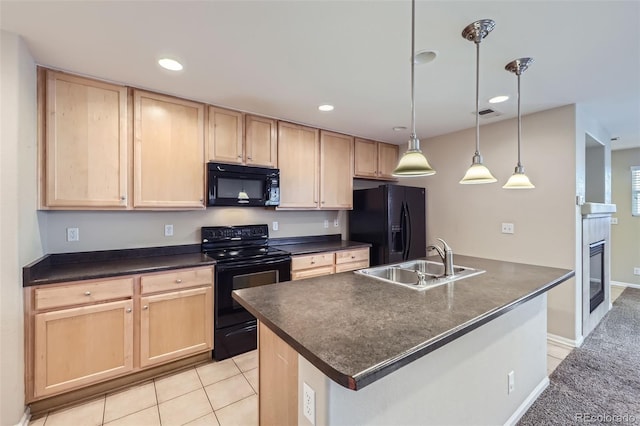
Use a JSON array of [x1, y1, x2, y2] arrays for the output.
[[353, 138, 398, 180]]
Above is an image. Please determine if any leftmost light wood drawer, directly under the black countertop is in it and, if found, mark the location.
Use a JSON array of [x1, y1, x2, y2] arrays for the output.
[[35, 277, 133, 310]]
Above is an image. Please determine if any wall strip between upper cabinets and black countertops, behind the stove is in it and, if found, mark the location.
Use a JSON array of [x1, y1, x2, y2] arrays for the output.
[[40, 207, 346, 253]]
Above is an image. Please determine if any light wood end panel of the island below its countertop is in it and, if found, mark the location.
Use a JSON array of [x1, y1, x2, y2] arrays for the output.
[[258, 323, 298, 426]]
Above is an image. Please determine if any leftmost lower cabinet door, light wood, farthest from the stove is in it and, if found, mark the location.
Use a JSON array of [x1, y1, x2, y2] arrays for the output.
[[34, 300, 133, 397]]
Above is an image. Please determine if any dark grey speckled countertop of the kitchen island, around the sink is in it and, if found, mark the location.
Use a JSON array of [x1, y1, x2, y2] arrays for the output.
[[233, 255, 575, 390]]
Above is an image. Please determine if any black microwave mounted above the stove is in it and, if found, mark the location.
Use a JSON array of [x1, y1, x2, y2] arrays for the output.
[[207, 163, 280, 207]]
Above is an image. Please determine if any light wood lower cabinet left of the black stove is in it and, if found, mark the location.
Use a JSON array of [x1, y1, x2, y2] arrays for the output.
[[25, 266, 213, 403]]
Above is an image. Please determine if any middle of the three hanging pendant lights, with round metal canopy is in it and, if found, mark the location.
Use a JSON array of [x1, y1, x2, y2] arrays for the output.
[[460, 19, 497, 184]]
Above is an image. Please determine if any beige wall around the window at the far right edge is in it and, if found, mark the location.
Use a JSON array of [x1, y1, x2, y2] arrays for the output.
[[611, 148, 640, 285]]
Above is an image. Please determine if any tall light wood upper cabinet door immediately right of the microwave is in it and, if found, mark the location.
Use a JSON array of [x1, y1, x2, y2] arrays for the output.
[[278, 122, 320, 209]]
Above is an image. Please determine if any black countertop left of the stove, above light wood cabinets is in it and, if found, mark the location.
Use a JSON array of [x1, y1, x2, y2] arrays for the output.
[[22, 244, 216, 287]]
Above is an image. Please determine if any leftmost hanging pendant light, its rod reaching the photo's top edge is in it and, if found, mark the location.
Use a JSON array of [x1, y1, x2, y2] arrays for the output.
[[392, 0, 436, 177]]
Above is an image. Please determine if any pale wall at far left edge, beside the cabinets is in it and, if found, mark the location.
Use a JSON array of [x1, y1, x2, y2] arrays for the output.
[[0, 31, 42, 425]]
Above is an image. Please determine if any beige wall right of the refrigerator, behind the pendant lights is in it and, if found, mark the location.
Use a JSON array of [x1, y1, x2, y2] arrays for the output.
[[402, 105, 584, 340]]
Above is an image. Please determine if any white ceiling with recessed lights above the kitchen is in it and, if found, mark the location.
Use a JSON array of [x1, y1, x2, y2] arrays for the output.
[[0, 0, 640, 149]]
